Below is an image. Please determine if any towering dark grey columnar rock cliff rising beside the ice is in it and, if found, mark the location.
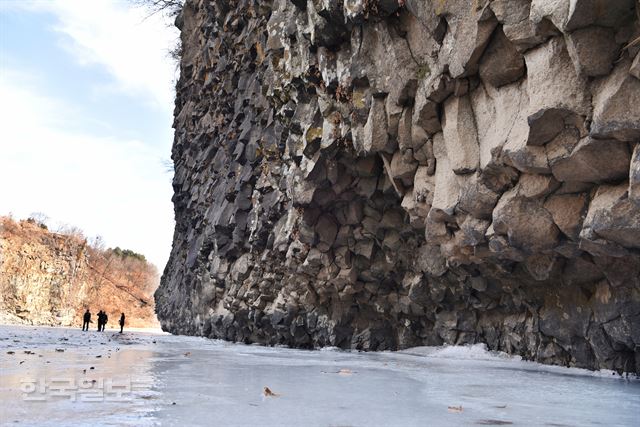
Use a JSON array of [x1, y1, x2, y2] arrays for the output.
[[156, 0, 640, 372]]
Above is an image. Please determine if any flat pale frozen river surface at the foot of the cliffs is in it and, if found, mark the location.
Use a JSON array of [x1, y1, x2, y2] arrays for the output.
[[0, 326, 640, 427]]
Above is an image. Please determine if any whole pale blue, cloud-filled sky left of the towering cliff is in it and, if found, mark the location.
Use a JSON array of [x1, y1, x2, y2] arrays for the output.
[[0, 0, 178, 269]]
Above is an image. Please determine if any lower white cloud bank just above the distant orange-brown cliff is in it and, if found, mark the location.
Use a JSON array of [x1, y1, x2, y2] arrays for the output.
[[0, 71, 173, 269]]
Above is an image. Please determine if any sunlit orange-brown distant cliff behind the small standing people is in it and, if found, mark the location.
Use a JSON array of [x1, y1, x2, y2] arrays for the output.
[[0, 217, 158, 327]]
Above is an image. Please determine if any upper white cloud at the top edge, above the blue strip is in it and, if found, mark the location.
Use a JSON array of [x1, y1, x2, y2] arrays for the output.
[[15, 0, 178, 112]]
